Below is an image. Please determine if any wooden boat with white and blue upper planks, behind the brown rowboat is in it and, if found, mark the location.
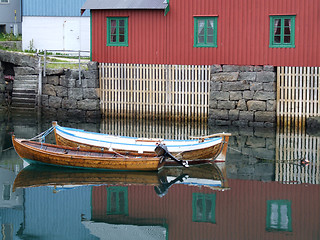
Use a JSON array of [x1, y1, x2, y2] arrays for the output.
[[53, 122, 230, 164]]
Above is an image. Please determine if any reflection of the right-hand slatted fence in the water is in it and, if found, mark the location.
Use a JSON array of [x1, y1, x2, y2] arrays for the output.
[[276, 129, 320, 184]]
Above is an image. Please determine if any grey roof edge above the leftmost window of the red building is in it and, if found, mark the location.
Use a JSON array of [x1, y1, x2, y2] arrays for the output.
[[81, 0, 168, 11]]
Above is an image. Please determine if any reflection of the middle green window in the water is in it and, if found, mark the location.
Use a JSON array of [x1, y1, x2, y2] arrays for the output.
[[192, 193, 216, 223]]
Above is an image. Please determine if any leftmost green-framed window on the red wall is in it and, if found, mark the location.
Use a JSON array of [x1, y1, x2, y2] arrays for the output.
[[107, 17, 128, 46]]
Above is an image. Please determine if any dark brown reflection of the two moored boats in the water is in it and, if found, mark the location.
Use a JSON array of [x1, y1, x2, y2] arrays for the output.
[[13, 163, 227, 196]]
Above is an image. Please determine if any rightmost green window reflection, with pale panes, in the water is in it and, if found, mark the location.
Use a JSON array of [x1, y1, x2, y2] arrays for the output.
[[267, 200, 292, 232]]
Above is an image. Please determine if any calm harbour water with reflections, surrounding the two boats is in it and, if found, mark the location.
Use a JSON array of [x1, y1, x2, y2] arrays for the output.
[[0, 112, 320, 240]]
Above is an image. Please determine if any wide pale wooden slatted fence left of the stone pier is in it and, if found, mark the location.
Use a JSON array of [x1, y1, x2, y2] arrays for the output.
[[99, 63, 210, 120]]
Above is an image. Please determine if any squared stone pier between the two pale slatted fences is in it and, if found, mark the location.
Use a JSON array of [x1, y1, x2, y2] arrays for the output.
[[209, 65, 276, 127]]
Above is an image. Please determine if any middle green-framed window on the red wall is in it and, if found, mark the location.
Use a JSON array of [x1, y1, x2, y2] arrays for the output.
[[194, 17, 218, 47]]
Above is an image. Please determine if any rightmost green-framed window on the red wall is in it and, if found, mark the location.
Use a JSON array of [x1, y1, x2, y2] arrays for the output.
[[270, 15, 295, 48]]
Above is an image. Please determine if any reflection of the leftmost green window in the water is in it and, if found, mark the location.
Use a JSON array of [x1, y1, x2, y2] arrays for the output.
[[107, 187, 128, 215]]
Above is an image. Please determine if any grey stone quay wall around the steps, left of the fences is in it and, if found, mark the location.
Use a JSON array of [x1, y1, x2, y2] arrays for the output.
[[0, 50, 101, 120]]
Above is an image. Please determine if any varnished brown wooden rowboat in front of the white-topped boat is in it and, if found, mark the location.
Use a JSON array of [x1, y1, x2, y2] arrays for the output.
[[12, 136, 164, 171]]
